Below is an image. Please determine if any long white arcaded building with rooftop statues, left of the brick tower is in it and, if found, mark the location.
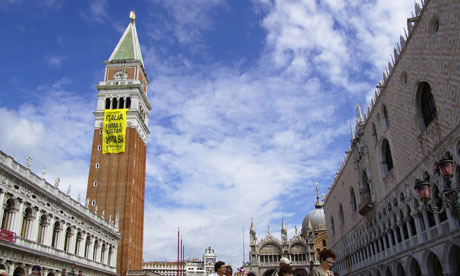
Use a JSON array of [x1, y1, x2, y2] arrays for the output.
[[0, 151, 120, 276]]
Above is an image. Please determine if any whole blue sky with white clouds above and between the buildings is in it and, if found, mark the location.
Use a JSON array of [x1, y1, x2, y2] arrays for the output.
[[0, 0, 419, 266]]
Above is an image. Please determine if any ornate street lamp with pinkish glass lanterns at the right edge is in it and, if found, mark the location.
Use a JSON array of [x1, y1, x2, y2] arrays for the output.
[[414, 158, 460, 219]]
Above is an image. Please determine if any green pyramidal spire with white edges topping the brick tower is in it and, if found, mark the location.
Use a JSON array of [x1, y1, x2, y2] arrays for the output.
[[109, 12, 144, 66]]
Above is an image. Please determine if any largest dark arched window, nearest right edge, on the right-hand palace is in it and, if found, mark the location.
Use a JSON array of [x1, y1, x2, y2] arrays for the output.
[[417, 82, 438, 130]]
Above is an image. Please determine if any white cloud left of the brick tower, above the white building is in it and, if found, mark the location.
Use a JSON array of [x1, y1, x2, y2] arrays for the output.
[[0, 77, 93, 203]]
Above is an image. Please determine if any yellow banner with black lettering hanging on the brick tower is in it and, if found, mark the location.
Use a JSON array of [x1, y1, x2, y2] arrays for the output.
[[102, 109, 128, 153]]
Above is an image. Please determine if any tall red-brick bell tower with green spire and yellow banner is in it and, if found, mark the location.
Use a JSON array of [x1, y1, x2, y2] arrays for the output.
[[86, 12, 152, 276]]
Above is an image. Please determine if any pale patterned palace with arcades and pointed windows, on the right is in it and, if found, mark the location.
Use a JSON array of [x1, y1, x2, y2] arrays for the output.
[[324, 0, 460, 276]]
